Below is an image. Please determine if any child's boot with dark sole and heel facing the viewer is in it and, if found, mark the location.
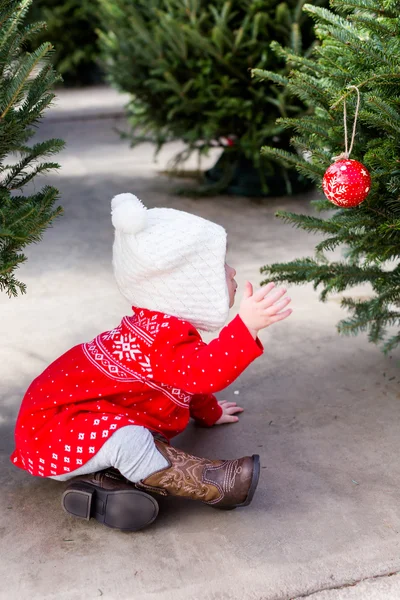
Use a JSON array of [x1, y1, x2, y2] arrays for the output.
[[62, 468, 158, 531]]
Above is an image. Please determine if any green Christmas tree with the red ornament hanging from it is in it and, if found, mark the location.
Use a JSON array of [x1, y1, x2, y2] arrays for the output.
[[256, 0, 400, 352]]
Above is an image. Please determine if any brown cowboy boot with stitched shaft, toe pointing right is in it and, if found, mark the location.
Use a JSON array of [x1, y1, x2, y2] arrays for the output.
[[136, 438, 260, 509]]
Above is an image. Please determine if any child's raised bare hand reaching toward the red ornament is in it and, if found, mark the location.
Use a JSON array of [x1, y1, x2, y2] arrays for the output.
[[239, 281, 292, 339]]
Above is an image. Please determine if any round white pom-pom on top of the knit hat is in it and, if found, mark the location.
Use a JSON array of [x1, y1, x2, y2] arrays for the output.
[[111, 193, 147, 235]]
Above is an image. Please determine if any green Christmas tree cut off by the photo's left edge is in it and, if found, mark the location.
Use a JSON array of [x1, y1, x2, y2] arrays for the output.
[[0, 0, 64, 296]]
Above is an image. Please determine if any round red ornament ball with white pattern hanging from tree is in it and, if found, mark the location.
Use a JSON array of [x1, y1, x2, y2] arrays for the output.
[[322, 158, 371, 208]]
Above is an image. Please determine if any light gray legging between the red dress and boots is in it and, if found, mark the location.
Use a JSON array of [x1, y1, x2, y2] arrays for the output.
[[50, 425, 168, 483]]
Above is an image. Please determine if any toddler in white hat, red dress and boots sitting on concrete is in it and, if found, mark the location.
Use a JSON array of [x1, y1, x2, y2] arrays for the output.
[[11, 194, 291, 531]]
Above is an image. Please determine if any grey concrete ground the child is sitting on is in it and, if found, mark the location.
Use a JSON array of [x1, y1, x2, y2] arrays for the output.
[[0, 89, 400, 600]]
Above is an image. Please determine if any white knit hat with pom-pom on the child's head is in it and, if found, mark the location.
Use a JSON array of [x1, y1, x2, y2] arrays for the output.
[[111, 194, 229, 331]]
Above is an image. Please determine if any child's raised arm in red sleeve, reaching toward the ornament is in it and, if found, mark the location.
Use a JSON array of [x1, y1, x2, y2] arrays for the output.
[[151, 283, 291, 394]]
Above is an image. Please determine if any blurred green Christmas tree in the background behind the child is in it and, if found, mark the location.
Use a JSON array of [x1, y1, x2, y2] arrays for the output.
[[99, 0, 326, 195]]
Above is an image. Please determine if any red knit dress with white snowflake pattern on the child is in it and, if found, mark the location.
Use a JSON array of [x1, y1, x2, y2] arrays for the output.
[[11, 307, 263, 477]]
